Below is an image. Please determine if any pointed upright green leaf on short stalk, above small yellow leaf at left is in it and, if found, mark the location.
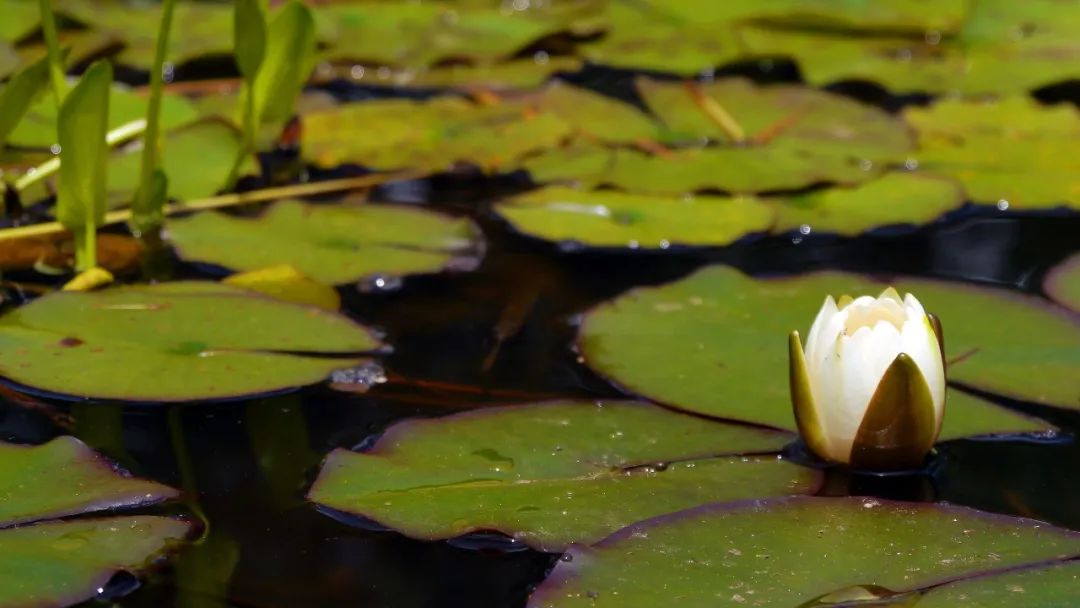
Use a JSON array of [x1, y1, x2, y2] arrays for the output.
[[56, 62, 112, 270]]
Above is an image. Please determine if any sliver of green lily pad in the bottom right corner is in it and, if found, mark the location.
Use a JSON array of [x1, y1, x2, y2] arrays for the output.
[[918, 562, 1080, 608]]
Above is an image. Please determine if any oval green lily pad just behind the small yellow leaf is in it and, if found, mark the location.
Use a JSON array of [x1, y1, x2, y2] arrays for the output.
[[166, 201, 481, 284]]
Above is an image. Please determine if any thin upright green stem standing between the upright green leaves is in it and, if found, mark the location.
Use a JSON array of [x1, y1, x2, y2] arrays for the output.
[[132, 0, 176, 230]]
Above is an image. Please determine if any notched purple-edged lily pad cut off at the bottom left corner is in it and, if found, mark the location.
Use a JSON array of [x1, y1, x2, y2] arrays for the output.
[[0, 436, 189, 607]]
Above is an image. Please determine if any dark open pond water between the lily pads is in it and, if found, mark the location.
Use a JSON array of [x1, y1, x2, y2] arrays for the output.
[[0, 69, 1080, 608]]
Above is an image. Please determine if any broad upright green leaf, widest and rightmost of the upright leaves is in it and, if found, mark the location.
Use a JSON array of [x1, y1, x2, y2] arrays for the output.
[[252, 0, 315, 123]]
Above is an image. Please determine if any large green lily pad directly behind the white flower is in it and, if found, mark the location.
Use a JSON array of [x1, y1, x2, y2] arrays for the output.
[[579, 267, 1080, 431]]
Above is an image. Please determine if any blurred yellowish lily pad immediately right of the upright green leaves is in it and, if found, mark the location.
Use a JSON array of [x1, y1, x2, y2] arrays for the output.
[[301, 97, 569, 171]]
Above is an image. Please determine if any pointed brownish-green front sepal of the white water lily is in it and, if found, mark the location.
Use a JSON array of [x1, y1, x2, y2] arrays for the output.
[[850, 353, 937, 470]]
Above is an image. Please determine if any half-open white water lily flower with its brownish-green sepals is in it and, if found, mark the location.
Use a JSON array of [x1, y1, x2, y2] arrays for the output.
[[788, 287, 945, 469]]
